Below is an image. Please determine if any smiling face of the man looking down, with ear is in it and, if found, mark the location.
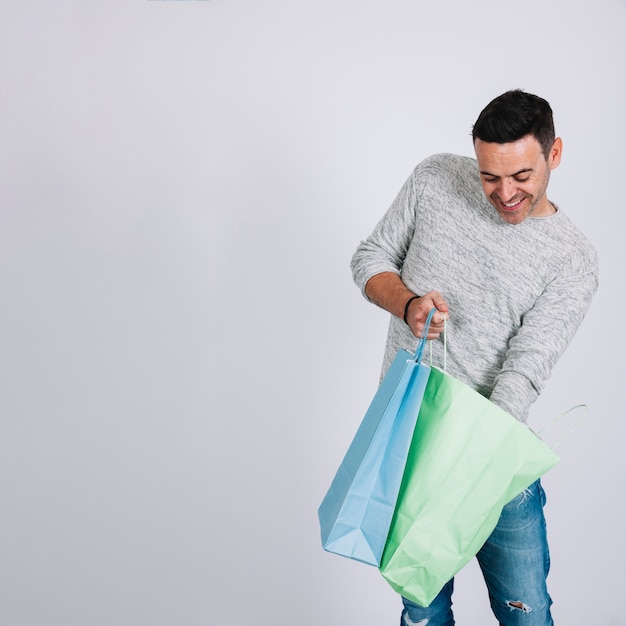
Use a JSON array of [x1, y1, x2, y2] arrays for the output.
[[474, 135, 562, 224]]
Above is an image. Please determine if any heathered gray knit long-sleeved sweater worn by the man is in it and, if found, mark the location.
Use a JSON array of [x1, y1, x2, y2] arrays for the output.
[[352, 154, 598, 421]]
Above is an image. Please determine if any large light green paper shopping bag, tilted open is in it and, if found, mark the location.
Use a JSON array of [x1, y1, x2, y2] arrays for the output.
[[380, 367, 559, 606]]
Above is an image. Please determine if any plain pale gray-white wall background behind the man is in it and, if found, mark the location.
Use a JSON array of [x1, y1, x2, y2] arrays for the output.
[[0, 0, 626, 626]]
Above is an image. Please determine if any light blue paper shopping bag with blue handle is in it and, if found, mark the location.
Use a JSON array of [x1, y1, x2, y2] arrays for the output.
[[318, 311, 433, 566]]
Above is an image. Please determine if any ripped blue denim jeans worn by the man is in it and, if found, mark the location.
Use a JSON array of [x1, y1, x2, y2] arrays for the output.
[[401, 481, 554, 626]]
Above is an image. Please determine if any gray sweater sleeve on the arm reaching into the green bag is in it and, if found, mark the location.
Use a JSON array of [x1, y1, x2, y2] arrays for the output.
[[491, 247, 598, 421]]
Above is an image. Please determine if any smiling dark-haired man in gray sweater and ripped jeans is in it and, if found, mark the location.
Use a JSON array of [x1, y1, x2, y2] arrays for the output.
[[352, 90, 598, 626]]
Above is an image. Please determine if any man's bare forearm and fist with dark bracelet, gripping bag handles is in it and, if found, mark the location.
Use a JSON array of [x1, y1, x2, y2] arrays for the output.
[[365, 272, 448, 339]]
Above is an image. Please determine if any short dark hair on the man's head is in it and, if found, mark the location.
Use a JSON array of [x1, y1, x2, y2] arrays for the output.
[[472, 89, 555, 159]]
